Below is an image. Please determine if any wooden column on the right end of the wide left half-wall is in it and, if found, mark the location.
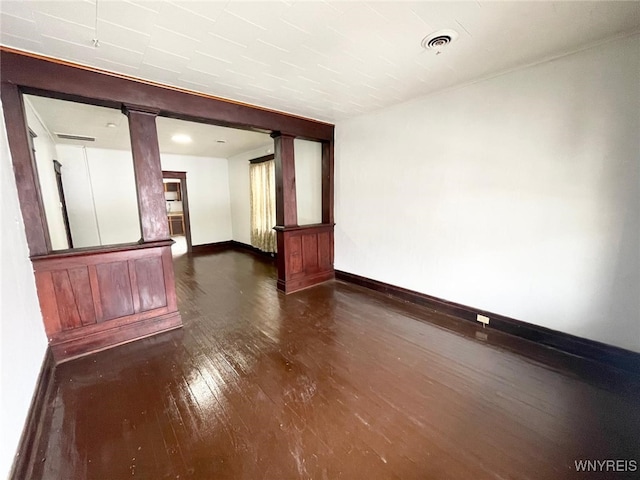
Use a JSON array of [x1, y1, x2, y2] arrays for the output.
[[122, 105, 169, 243]]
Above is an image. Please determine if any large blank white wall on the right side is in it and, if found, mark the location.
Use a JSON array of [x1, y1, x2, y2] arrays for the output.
[[335, 35, 640, 352]]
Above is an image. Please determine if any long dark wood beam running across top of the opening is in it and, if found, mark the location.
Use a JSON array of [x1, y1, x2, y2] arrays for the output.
[[0, 47, 334, 141]]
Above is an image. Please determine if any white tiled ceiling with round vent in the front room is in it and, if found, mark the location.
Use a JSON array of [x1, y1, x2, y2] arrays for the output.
[[0, 0, 640, 122]]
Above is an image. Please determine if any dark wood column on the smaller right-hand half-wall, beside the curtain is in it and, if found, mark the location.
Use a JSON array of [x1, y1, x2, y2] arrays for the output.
[[271, 132, 298, 227]]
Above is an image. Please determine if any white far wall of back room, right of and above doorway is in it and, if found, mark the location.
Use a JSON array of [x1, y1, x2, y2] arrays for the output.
[[160, 153, 232, 245]]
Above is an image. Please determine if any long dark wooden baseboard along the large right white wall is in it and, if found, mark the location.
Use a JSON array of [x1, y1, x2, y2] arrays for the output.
[[336, 270, 640, 374]]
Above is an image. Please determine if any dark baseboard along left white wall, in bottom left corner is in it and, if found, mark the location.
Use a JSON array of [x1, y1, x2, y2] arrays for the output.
[[9, 348, 55, 480]]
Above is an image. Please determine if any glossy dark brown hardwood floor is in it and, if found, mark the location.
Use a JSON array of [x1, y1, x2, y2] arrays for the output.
[[25, 251, 640, 480]]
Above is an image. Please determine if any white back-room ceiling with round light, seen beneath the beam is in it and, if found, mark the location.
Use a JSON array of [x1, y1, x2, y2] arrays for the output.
[[25, 95, 273, 158]]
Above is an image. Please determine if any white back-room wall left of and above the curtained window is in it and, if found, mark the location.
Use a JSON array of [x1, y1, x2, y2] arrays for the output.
[[229, 143, 273, 245]]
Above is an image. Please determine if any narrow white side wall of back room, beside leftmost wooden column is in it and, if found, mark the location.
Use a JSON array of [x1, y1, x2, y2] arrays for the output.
[[23, 97, 69, 250]]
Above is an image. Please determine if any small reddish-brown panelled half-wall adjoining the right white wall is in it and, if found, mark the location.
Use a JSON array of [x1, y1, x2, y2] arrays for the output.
[[275, 224, 334, 293]]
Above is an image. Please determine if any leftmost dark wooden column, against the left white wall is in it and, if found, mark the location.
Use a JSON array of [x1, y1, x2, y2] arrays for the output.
[[0, 82, 51, 256]]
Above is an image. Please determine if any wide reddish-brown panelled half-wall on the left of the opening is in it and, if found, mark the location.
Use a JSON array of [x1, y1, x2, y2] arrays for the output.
[[32, 240, 182, 362]]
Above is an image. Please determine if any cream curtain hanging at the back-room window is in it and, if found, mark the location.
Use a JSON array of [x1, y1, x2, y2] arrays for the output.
[[249, 160, 276, 252]]
